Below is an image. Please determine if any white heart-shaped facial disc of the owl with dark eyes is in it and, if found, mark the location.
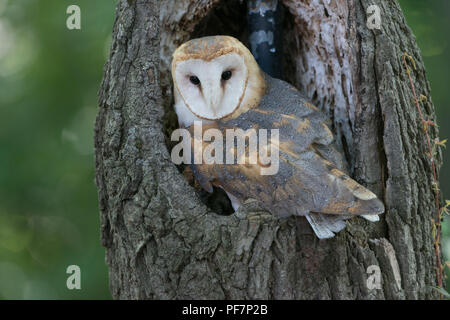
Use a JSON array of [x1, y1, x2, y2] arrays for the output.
[[175, 53, 248, 120]]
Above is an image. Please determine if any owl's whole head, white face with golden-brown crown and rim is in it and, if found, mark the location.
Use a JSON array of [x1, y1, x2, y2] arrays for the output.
[[172, 36, 265, 120]]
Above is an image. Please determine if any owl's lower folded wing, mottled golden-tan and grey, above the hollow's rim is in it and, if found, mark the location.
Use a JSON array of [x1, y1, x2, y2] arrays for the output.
[[191, 128, 384, 216]]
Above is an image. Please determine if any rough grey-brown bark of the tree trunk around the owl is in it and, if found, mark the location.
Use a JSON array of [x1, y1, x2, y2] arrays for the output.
[[95, 0, 440, 299]]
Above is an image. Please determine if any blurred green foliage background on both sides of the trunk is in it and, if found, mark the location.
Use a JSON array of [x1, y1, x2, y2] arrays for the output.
[[0, 0, 450, 299]]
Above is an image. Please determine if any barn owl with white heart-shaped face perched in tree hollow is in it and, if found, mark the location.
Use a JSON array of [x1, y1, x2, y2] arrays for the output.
[[172, 36, 384, 239]]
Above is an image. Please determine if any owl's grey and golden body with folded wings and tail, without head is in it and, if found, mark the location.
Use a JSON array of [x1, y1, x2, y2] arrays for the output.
[[186, 75, 384, 238]]
